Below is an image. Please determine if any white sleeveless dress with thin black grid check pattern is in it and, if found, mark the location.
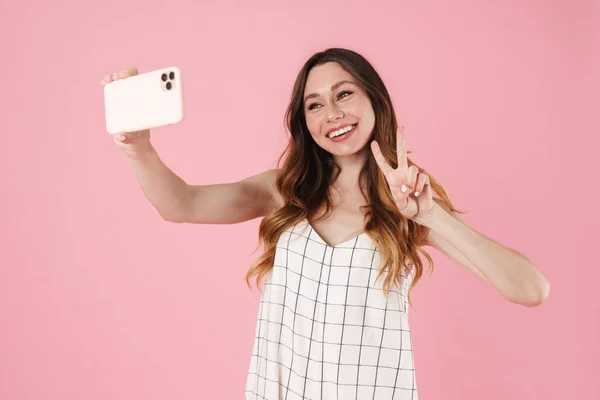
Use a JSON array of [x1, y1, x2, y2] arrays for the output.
[[245, 219, 418, 400]]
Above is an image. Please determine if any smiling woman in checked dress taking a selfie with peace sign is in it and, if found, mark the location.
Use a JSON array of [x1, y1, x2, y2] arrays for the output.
[[102, 49, 549, 399]]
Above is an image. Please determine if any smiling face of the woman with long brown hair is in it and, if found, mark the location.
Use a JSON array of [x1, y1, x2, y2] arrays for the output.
[[304, 62, 375, 156]]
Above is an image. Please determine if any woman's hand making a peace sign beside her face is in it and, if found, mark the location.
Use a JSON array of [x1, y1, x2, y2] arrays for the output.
[[371, 126, 436, 221]]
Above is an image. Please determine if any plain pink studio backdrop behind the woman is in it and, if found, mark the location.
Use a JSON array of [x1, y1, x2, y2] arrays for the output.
[[0, 0, 600, 400]]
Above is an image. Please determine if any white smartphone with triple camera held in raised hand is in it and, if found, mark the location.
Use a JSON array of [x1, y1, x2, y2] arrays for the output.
[[104, 67, 184, 135]]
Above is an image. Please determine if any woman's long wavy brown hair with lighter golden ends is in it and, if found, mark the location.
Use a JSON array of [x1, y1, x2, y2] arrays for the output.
[[246, 48, 462, 306]]
